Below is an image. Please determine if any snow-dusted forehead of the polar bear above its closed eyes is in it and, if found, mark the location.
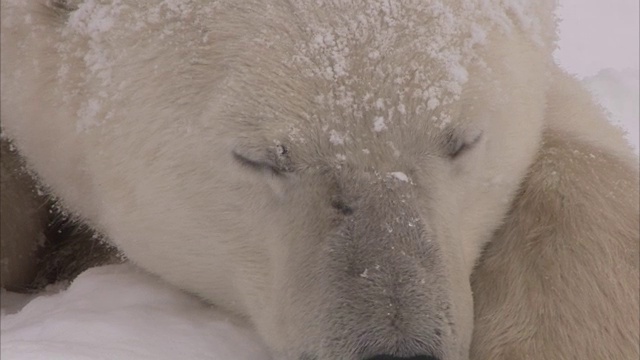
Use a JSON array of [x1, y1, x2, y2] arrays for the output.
[[232, 0, 492, 163]]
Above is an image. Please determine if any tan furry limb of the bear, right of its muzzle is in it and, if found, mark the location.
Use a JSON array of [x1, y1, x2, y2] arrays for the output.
[[471, 69, 640, 360]]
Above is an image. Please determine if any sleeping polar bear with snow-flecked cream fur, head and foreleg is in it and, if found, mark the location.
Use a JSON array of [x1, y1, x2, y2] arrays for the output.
[[1, 0, 639, 360]]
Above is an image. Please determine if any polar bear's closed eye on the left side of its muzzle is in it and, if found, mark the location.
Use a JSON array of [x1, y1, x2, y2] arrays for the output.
[[231, 139, 293, 175]]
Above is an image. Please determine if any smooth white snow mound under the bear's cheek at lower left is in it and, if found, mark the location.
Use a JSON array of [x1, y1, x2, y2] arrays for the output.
[[0, 265, 269, 360]]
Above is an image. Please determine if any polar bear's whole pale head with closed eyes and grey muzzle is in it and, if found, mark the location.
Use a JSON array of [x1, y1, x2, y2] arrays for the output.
[[3, 0, 553, 360]]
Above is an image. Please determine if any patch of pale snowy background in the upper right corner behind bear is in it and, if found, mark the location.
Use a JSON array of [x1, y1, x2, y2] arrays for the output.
[[556, 0, 640, 153]]
